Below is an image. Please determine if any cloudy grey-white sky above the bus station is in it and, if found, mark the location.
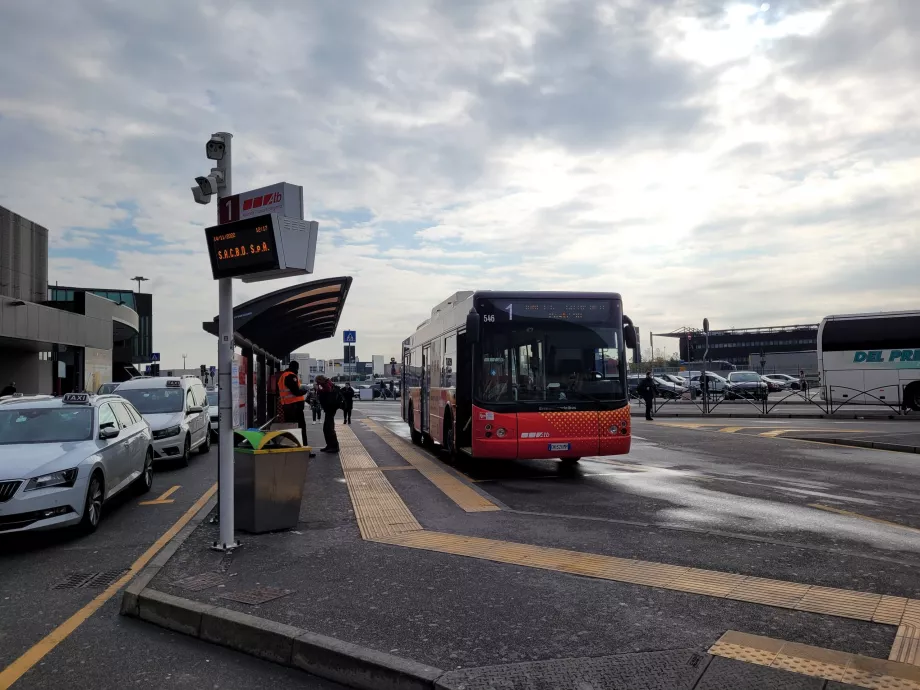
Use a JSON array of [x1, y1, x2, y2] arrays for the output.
[[0, 0, 920, 367]]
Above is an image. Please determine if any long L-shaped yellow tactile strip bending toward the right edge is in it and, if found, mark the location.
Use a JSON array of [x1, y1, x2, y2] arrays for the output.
[[340, 420, 920, 668]]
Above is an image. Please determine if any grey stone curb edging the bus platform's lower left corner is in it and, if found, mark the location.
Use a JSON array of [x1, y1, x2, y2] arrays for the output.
[[121, 486, 445, 690]]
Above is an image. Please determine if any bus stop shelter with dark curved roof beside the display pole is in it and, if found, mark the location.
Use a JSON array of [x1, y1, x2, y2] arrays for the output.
[[202, 277, 351, 428]]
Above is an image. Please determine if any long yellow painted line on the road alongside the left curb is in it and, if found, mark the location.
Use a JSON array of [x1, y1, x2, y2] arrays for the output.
[[0, 484, 217, 690]]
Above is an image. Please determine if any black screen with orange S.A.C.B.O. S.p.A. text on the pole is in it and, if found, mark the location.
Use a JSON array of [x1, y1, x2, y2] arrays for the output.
[[205, 213, 280, 280]]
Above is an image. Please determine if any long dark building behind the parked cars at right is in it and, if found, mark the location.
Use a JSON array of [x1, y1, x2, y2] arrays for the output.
[[655, 324, 818, 370]]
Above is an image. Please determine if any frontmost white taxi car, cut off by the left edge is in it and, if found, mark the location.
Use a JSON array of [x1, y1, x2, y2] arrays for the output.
[[0, 393, 153, 534]]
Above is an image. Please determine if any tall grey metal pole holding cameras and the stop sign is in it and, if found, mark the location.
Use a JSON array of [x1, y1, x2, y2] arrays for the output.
[[214, 132, 239, 551]]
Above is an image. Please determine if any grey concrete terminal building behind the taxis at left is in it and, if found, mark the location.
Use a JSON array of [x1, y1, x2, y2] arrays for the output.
[[0, 206, 150, 395]]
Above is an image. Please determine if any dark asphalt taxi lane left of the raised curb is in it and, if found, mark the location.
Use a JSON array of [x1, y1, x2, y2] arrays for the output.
[[0, 450, 340, 689]]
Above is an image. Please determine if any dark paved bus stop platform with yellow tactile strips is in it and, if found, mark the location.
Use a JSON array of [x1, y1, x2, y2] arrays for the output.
[[123, 410, 920, 690]]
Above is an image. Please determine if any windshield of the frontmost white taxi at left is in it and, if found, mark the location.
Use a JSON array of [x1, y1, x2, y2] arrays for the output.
[[0, 407, 93, 445]]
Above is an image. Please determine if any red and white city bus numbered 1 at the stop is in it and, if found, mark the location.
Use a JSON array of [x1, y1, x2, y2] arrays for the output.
[[402, 292, 636, 463]]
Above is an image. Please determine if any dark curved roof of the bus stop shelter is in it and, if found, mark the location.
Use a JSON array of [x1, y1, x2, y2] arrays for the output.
[[202, 277, 351, 359]]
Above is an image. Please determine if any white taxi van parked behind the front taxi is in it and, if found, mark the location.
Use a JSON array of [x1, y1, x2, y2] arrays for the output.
[[118, 376, 211, 466]]
